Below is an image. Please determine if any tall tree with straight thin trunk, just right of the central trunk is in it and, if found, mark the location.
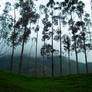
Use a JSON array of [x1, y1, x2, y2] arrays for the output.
[[53, 2, 67, 75]]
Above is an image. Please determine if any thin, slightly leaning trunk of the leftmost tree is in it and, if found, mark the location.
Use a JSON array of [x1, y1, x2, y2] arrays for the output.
[[10, 7, 16, 72]]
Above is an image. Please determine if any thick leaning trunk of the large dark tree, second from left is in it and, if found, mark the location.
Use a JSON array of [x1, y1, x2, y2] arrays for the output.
[[18, 26, 26, 74]]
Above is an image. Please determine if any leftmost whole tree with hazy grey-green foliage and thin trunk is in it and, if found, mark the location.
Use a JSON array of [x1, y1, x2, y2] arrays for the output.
[[1, 2, 19, 72]]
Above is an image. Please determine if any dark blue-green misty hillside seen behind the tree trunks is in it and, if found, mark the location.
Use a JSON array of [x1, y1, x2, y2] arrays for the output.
[[0, 55, 92, 76]]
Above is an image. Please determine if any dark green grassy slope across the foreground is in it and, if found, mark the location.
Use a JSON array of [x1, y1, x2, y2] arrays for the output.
[[0, 71, 92, 92]]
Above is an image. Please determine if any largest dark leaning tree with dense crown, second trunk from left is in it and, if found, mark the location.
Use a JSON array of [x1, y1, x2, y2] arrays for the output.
[[16, 0, 38, 74]]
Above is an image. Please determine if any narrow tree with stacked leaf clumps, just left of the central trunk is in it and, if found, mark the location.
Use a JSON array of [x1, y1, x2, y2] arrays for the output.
[[40, 5, 51, 75]]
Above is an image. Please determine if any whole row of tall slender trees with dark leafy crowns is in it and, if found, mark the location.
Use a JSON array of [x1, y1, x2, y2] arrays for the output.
[[0, 0, 92, 76]]
